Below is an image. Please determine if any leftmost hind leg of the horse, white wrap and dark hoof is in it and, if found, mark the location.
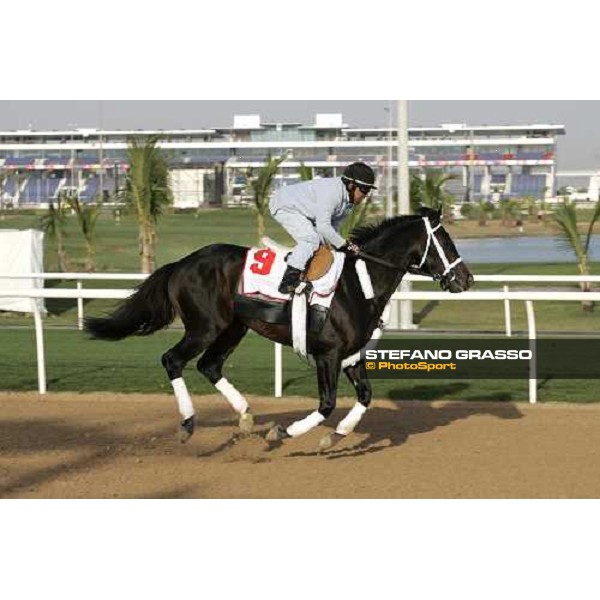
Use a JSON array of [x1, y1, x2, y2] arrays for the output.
[[162, 331, 213, 442]]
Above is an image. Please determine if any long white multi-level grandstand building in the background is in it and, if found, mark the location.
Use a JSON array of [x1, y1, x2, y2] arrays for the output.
[[0, 114, 565, 207]]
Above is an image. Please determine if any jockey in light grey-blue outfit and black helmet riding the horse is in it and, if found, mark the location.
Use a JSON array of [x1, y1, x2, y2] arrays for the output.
[[269, 162, 377, 294]]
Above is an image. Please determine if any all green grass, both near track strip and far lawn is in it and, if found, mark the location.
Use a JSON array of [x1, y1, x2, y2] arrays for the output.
[[0, 209, 600, 401]]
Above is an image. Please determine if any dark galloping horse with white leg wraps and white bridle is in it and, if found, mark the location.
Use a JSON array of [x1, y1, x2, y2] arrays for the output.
[[85, 209, 473, 447]]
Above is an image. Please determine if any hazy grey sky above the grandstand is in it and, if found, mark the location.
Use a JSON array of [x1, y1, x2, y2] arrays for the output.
[[0, 100, 600, 170]]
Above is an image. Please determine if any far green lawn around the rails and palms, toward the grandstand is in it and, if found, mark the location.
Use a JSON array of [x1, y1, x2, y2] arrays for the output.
[[0, 209, 600, 332]]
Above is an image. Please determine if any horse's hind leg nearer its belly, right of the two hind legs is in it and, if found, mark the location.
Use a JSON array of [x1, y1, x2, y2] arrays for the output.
[[197, 321, 254, 434]]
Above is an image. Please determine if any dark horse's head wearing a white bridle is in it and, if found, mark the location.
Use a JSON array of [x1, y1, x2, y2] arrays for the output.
[[409, 208, 473, 293]]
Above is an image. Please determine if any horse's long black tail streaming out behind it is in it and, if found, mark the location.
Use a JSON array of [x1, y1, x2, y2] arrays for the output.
[[85, 263, 177, 340]]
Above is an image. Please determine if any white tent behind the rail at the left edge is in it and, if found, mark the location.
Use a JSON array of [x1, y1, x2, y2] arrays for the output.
[[0, 229, 46, 313]]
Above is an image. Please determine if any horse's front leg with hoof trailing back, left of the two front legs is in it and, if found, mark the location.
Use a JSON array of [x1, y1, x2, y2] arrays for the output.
[[266, 353, 341, 442]]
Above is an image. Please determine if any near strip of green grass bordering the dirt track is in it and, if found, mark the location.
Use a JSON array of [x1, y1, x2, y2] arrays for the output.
[[0, 329, 599, 402]]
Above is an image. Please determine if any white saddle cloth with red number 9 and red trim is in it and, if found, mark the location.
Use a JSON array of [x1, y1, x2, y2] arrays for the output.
[[239, 248, 346, 308]]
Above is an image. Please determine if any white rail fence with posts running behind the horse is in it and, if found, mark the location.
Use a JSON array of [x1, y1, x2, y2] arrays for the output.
[[0, 273, 600, 404]]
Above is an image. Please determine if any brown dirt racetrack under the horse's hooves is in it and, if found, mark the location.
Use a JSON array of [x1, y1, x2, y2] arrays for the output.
[[0, 392, 600, 498]]
